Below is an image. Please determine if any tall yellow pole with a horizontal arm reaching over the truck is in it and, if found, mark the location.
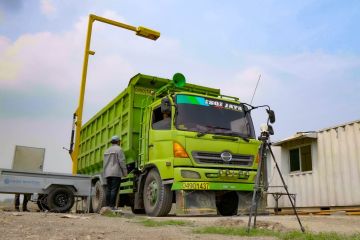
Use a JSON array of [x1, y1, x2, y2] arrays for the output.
[[69, 14, 160, 174]]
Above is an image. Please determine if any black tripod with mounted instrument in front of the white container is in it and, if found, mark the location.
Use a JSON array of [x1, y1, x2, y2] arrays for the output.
[[247, 124, 305, 232]]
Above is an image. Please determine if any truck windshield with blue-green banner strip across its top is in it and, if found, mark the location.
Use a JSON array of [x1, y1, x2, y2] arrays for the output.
[[175, 94, 254, 137]]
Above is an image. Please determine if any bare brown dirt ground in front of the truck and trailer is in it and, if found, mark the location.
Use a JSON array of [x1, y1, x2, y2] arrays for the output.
[[0, 201, 360, 240]]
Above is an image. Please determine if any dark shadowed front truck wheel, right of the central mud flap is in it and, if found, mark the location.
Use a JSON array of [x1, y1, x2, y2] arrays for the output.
[[216, 192, 239, 216]]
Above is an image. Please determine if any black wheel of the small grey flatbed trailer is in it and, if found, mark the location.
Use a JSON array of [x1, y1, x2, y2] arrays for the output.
[[47, 187, 74, 213]]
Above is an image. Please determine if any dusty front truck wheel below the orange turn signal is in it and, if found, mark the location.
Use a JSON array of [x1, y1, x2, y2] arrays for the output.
[[143, 169, 173, 217]]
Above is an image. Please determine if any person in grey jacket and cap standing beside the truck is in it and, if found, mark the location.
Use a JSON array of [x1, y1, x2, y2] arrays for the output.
[[103, 136, 127, 209]]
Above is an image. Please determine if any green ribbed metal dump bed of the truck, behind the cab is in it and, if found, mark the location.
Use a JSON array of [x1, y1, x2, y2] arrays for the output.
[[78, 74, 220, 174]]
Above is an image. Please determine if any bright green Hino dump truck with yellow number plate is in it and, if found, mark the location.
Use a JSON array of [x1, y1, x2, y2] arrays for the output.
[[70, 74, 268, 216]]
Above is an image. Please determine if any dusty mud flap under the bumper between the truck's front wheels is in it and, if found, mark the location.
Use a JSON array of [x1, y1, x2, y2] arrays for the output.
[[175, 190, 217, 216]]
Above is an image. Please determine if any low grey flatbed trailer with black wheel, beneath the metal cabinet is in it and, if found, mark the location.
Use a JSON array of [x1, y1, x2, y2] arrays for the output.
[[0, 168, 92, 212]]
